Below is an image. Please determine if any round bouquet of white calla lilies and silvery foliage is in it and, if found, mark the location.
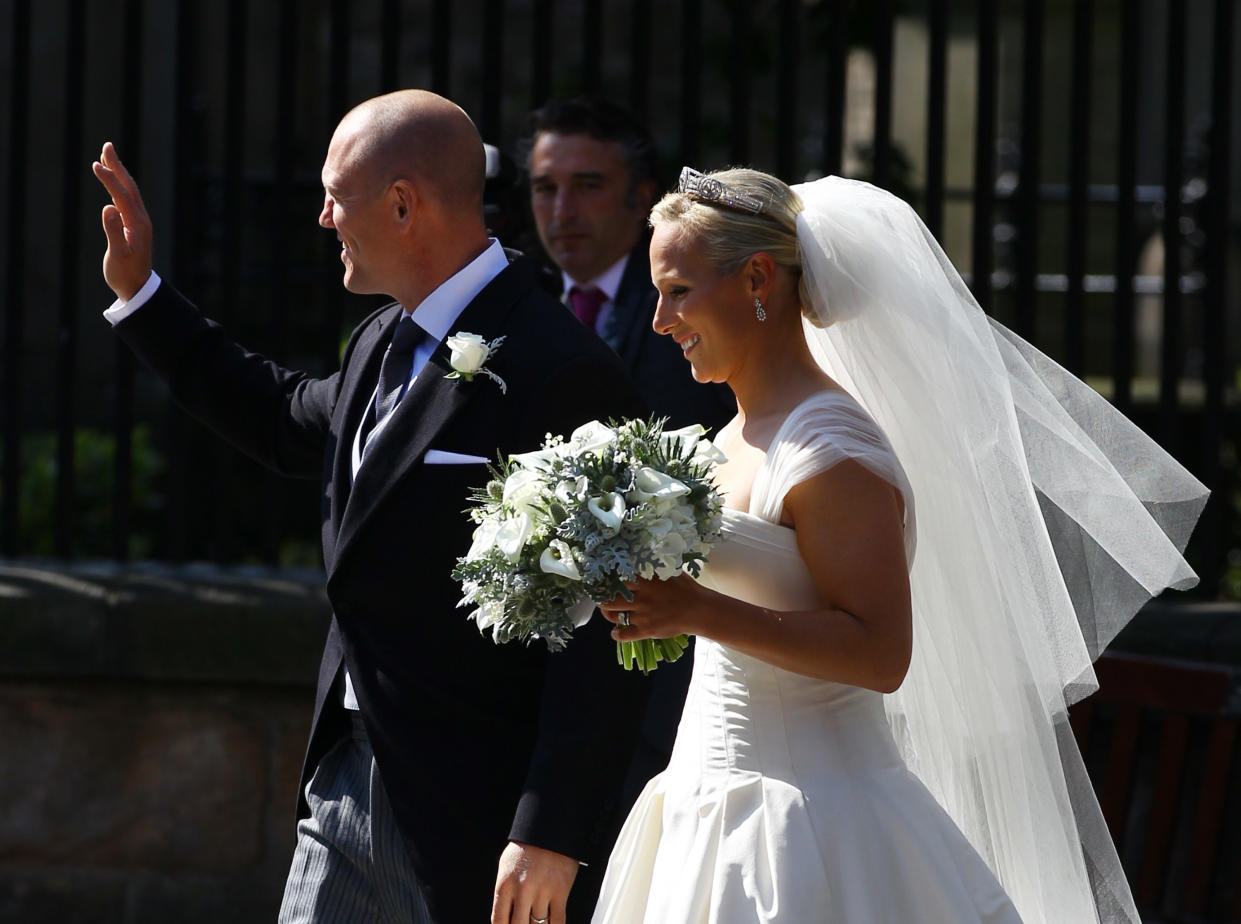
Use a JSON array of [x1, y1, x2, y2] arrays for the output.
[[453, 420, 724, 672]]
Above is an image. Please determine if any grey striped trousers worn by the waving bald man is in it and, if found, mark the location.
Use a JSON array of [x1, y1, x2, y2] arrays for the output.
[[279, 718, 432, 924]]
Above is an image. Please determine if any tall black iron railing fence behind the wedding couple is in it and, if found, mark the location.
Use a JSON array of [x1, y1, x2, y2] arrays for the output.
[[0, 0, 1241, 597]]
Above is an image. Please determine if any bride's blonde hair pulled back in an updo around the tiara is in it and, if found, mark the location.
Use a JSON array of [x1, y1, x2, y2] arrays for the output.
[[650, 167, 819, 325]]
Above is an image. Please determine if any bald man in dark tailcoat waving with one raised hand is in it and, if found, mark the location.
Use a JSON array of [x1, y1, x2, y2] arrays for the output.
[[93, 91, 645, 924]]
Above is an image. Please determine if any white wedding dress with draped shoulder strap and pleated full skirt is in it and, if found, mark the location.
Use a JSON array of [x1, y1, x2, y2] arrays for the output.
[[593, 392, 1020, 924]]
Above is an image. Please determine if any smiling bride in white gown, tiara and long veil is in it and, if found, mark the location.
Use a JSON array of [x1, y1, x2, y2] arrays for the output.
[[593, 169, 1205, 924]]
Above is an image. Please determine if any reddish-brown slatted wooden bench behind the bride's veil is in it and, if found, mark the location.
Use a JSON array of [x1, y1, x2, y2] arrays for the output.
[[1070, 654, 1241, 924]]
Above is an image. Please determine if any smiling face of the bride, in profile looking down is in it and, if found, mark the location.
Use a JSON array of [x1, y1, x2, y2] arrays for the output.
[[650, 222, 755, 382]]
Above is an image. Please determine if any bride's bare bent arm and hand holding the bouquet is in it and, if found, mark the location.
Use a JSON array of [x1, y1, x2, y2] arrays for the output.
[[602, 461, 913, 693]]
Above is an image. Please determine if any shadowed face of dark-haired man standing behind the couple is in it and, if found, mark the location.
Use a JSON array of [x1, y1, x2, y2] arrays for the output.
[[530, 133, 652, 283]]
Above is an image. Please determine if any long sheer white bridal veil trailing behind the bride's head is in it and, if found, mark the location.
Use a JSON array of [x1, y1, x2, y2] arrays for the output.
[[793, 177, 1207, 924]]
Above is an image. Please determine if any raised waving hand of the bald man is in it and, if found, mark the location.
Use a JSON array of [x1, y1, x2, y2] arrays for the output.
[[91, 141, 151, 301]]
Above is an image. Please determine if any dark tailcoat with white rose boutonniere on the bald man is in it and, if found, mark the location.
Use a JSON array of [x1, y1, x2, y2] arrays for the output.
[[117, 258, 645, 923]]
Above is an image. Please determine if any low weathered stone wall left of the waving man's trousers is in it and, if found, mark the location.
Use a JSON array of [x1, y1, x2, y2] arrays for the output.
[[0, 562, 329, 924]]
